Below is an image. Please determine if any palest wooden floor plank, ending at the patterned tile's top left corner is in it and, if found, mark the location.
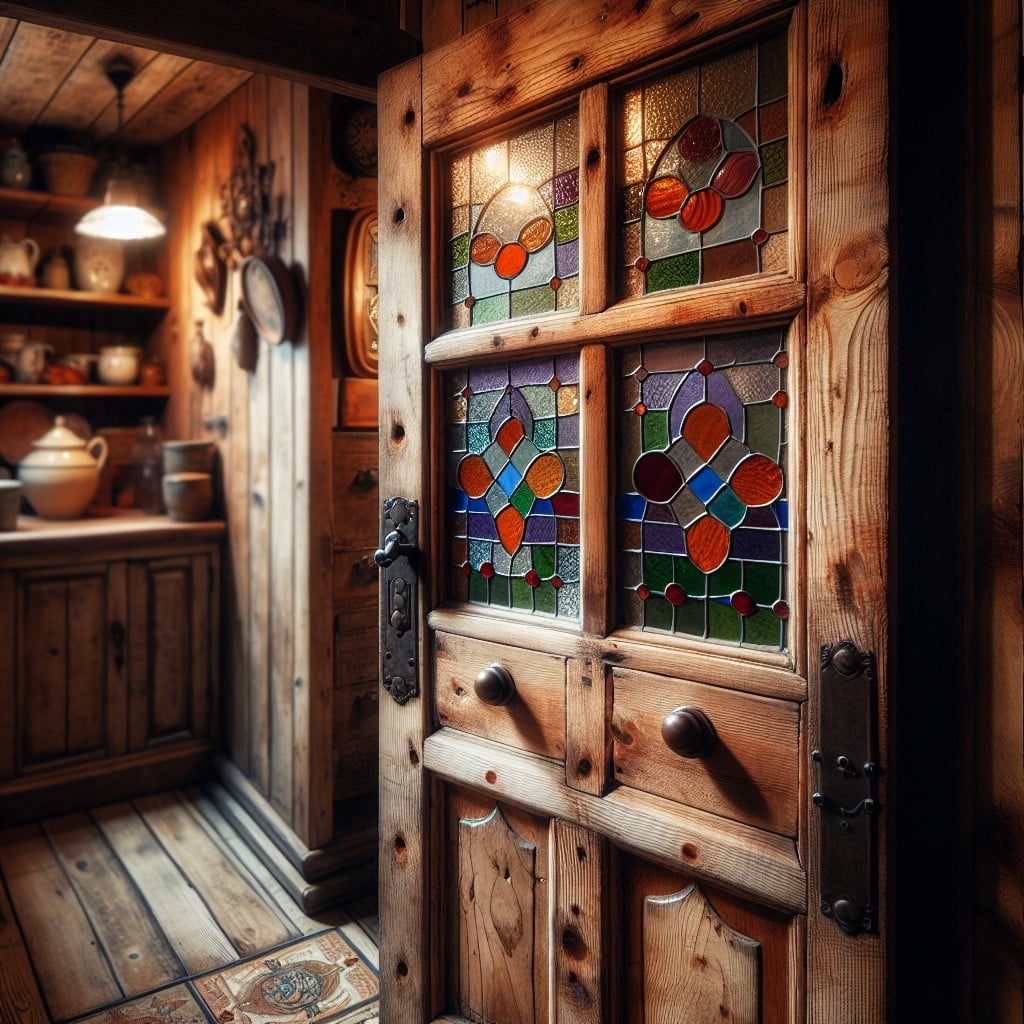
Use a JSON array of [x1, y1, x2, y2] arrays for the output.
[[91, 804, 240, 974]]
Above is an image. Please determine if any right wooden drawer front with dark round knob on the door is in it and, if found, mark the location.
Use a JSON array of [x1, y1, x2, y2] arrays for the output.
[[611, 669, 800, 836]]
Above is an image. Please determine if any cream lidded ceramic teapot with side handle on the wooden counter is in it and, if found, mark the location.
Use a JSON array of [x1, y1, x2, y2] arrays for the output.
[[17, 416, 106, 519]]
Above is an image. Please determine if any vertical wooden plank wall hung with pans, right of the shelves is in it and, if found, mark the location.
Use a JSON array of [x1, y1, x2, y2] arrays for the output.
[[160, 76, 332, 847]]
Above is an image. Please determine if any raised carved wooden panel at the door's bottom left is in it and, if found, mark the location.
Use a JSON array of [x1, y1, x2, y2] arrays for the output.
[[459, 807, 538, 1024]]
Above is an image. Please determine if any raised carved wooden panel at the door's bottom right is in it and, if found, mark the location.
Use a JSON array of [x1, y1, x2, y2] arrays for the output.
[[643, 883, 761, 1024]]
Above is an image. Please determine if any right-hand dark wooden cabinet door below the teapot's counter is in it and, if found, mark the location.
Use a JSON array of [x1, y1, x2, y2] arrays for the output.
[[127, 554, 218, 751]]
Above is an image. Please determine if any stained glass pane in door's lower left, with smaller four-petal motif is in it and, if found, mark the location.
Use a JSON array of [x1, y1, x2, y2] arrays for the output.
[[445, 355, 580, 618]]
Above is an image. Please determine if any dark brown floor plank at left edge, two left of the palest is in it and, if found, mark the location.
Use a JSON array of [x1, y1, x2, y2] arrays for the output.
[[0, 825, 122, 1020]]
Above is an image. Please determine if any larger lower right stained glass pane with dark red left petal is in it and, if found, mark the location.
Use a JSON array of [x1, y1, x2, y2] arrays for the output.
[[617, 329, 790, 650]]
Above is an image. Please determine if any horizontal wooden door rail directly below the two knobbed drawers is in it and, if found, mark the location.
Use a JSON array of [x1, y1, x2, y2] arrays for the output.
[[421, 729, 807, 913]]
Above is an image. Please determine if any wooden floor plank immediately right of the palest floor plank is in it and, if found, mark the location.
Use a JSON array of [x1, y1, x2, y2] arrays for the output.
[[133, 794, 301, 956]]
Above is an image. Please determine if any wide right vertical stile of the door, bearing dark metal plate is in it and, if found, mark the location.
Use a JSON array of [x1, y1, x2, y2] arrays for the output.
[[805, 2, 891, 1024]]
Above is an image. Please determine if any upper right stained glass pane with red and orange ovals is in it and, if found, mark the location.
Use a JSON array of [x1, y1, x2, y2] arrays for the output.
[[618, 33, 788, 297]]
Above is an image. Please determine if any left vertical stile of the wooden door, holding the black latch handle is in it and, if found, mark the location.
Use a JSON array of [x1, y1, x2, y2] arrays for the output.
[[378, 59, 436, 1024]]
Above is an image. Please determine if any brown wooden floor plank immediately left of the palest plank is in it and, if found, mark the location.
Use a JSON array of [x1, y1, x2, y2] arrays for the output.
[[43, 814, 184, 995]]
